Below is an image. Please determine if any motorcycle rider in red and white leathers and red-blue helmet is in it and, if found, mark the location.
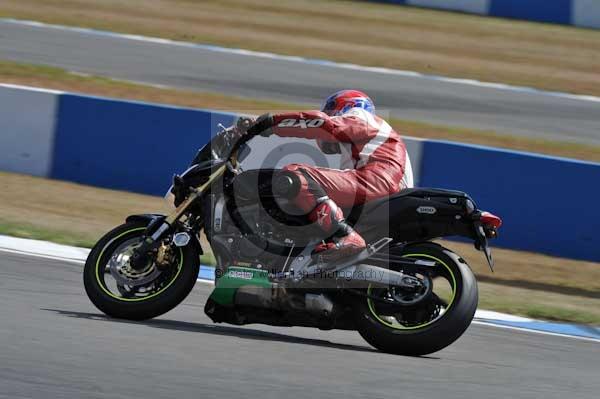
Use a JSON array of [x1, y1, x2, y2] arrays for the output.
[[247, 90, 413, 261]]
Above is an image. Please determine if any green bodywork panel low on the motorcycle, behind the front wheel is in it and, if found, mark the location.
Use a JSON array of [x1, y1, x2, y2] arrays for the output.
[[210, 266, 272, 306]]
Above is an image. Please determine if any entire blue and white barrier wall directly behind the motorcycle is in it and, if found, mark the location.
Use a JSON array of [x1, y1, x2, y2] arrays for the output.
[[0, 85, 600, 261]]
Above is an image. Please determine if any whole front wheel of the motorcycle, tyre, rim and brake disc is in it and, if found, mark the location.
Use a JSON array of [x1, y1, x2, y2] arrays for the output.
[[83, 222, 200, 320]]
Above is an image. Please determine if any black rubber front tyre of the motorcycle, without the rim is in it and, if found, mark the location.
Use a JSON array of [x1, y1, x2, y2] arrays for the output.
[[83, 222, 200, 320]]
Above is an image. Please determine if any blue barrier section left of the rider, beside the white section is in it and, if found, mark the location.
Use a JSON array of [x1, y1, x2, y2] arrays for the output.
[[50, 94, 234, 195]]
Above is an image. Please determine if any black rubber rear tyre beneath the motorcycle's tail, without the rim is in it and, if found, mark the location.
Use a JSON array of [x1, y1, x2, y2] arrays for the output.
[[356, 243, 478, 356]]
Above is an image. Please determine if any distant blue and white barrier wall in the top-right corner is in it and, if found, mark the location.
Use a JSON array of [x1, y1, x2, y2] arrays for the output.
[[369, 0, 600, 28]]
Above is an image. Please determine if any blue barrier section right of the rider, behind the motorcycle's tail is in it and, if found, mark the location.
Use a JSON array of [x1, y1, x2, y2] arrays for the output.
[[421, 141, 600, 261]]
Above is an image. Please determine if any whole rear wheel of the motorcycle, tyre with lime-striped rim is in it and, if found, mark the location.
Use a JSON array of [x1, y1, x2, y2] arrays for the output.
[[356, 243, 478, 356]]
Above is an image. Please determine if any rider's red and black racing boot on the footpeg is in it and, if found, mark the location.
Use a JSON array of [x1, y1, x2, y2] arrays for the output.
[[309, 196, 367, 262]]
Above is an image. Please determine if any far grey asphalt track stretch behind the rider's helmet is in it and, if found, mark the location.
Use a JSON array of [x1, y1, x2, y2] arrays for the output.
[[0, 20, 600, 145]]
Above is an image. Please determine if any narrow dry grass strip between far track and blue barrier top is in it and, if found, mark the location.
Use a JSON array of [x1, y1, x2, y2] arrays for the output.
[[0, 60, 600, 162]]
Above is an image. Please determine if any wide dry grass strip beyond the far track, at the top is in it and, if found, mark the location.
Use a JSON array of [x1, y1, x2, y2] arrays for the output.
[[0, 0, 600, 95]]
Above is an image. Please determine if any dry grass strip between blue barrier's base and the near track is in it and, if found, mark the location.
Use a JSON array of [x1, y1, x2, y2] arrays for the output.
[[0, 172, 600, 325]]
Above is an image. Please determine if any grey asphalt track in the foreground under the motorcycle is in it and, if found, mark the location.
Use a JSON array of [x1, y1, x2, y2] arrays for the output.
[[0, 252, 600, 399]]
